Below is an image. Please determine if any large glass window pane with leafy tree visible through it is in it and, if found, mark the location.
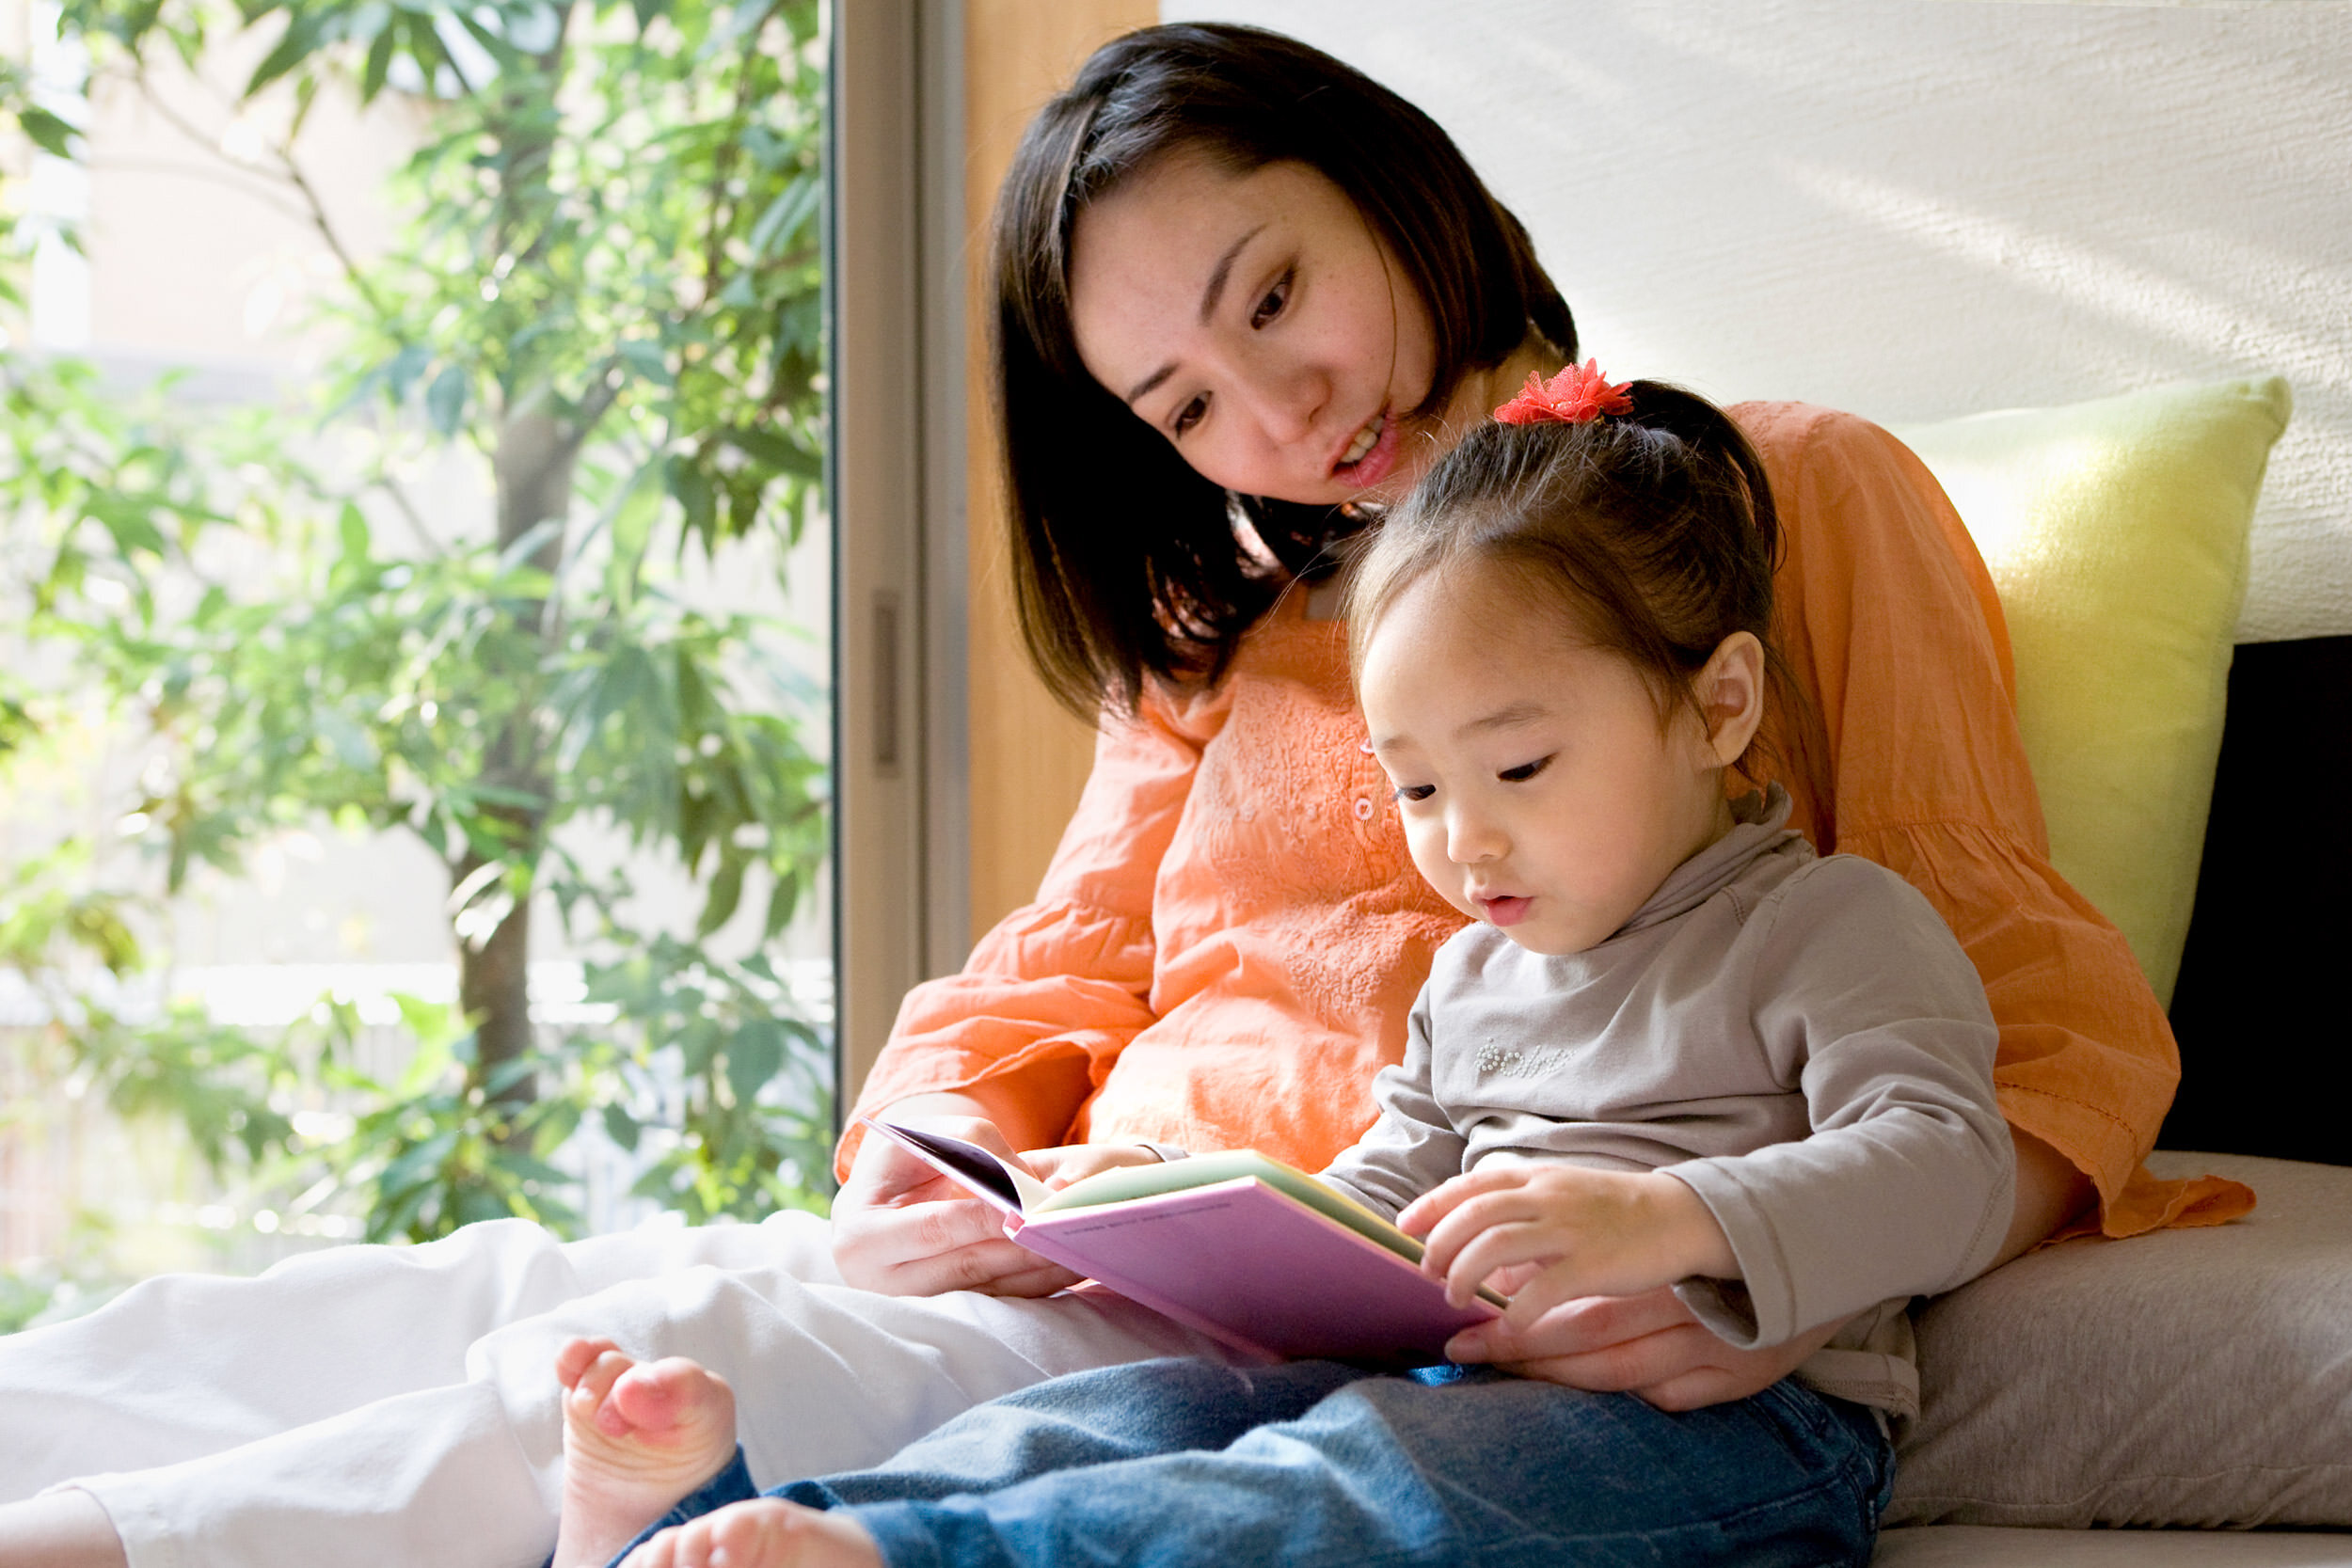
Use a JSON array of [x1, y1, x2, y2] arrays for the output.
[[0, 0, 833, 1331]]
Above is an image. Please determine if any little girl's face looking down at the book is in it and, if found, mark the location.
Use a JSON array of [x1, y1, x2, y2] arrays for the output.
[[1358, 569, 1762, 952]]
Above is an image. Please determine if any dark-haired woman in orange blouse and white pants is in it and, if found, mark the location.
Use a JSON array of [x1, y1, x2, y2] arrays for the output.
[[0, 28, 2242, 1568]]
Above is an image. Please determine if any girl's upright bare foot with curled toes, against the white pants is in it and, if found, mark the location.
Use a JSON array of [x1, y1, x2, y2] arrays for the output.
[[555, 1340, 734, 1568]]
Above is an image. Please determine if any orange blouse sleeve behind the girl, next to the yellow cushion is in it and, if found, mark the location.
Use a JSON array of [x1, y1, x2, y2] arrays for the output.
[[1736, 404, 2253, 1237]]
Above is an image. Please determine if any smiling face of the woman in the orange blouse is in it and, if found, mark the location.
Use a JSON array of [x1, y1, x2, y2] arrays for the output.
[[1071, 152, 1486, 505]]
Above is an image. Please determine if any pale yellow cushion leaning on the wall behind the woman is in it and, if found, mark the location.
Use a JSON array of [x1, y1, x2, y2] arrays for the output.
[[1896, 376, 2294, 1004]]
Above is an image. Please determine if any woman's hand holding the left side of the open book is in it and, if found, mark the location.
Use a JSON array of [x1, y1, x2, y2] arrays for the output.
[[833, 1117, 1082, 1295]]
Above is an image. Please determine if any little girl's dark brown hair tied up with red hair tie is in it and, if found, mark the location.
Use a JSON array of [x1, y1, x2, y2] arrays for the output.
[[1348, 381, 1809, 776]]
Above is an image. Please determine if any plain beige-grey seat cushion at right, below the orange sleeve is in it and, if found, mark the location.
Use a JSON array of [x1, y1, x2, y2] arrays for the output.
[[1886, 1152, 2352, 1528]]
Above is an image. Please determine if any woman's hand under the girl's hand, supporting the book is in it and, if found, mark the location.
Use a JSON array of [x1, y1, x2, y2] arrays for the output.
[[1447, 1286, 1844, 1411]]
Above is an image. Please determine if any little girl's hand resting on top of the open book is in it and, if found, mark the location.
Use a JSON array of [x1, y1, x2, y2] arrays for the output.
[[1397, 1164, 1739, 1328]]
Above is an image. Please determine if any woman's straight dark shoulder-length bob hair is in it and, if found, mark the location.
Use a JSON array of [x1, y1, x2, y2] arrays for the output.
[[991, 24, 1576, 720]]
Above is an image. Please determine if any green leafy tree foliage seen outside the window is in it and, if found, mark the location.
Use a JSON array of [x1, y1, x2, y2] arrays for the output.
[[0, 0, 831, 1325]]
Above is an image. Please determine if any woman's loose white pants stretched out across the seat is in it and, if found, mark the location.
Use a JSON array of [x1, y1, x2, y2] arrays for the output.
[[0, 1213, 1218, 1568]]
